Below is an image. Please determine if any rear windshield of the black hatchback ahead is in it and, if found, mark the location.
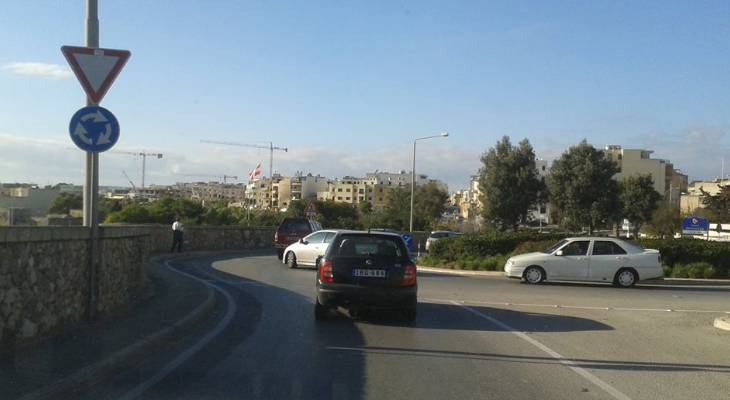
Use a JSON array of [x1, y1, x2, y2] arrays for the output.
[[332, 235, 408, 258]]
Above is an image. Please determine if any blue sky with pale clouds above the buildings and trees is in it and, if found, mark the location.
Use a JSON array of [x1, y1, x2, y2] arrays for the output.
[[0, 0, 730, 190]]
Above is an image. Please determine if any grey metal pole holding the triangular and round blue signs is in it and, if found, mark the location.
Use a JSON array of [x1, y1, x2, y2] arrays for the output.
[[84, 0, 99, 320]]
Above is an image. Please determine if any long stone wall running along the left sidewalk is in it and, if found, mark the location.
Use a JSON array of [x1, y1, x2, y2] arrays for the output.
[[0, 225, 274, 357]]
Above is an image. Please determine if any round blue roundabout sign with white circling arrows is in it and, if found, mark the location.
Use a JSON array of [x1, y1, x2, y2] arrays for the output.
[[68, 106, 119, 153]]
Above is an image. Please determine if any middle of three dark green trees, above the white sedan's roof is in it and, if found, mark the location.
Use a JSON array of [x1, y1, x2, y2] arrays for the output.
[[548, 139, 620, 234]]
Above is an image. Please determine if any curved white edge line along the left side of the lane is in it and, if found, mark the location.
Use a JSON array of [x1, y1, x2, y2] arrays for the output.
[[120, 260, 237, 400]]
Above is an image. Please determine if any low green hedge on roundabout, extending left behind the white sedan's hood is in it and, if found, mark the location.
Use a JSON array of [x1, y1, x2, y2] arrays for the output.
[[429, 231, 566, 262]]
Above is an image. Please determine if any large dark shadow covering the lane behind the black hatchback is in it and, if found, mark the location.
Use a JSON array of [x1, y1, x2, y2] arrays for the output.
[[136, 253, 365, 399]]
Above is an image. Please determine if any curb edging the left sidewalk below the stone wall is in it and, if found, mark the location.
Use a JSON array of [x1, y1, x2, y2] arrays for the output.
[[19, 257, 215, 400]]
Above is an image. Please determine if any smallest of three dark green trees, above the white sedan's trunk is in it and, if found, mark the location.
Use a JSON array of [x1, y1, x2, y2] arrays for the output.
[[621, 174, 662, 237]]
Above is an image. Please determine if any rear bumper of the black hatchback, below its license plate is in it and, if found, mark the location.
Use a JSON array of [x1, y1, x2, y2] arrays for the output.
[[317, 284, 418, 308]]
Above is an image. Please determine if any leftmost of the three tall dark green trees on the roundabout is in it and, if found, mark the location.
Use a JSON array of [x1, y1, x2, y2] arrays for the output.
[[479, 136, 542, 230]]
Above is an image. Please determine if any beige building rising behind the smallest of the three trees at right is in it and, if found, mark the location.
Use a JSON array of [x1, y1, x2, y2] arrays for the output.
[[604, 145, 687, 205]]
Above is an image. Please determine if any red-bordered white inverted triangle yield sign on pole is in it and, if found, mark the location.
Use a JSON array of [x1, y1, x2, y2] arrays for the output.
[[61, 46, 132, 104]]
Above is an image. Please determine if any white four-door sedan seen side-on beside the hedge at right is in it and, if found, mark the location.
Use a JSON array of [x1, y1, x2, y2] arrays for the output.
[[504, 237, 664, 287]]
